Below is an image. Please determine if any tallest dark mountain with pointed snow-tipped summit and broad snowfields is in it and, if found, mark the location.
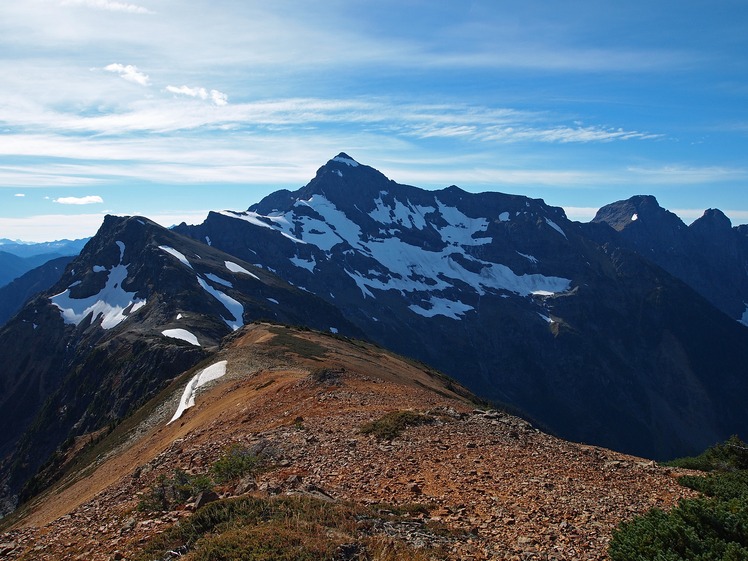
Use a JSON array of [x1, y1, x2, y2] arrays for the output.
[[176, 154, 748, 458]]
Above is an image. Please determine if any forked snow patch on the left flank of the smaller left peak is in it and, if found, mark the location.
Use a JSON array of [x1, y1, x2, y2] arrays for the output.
[[50, 241, 146, 329]]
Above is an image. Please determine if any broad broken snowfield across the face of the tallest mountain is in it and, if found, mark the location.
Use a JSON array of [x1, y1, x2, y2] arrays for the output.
[[222, 191, 571, 310]]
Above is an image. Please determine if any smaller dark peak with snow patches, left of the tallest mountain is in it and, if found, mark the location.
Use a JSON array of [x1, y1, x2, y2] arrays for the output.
[[0, 217, 360, 506]]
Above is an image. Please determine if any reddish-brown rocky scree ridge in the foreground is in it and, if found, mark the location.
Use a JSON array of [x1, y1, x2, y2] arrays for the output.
[[0, 325, 690, 561]]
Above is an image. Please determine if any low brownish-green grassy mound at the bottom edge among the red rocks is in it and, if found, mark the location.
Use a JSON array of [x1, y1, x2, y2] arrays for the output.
[[136, 496, 443, 561]]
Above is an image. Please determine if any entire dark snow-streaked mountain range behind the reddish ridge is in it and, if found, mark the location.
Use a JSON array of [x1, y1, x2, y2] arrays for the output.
[[0, 153, 748, 510]]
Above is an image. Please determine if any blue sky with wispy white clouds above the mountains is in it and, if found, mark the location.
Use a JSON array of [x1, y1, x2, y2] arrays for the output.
[[0, 0, 748, 241]]
